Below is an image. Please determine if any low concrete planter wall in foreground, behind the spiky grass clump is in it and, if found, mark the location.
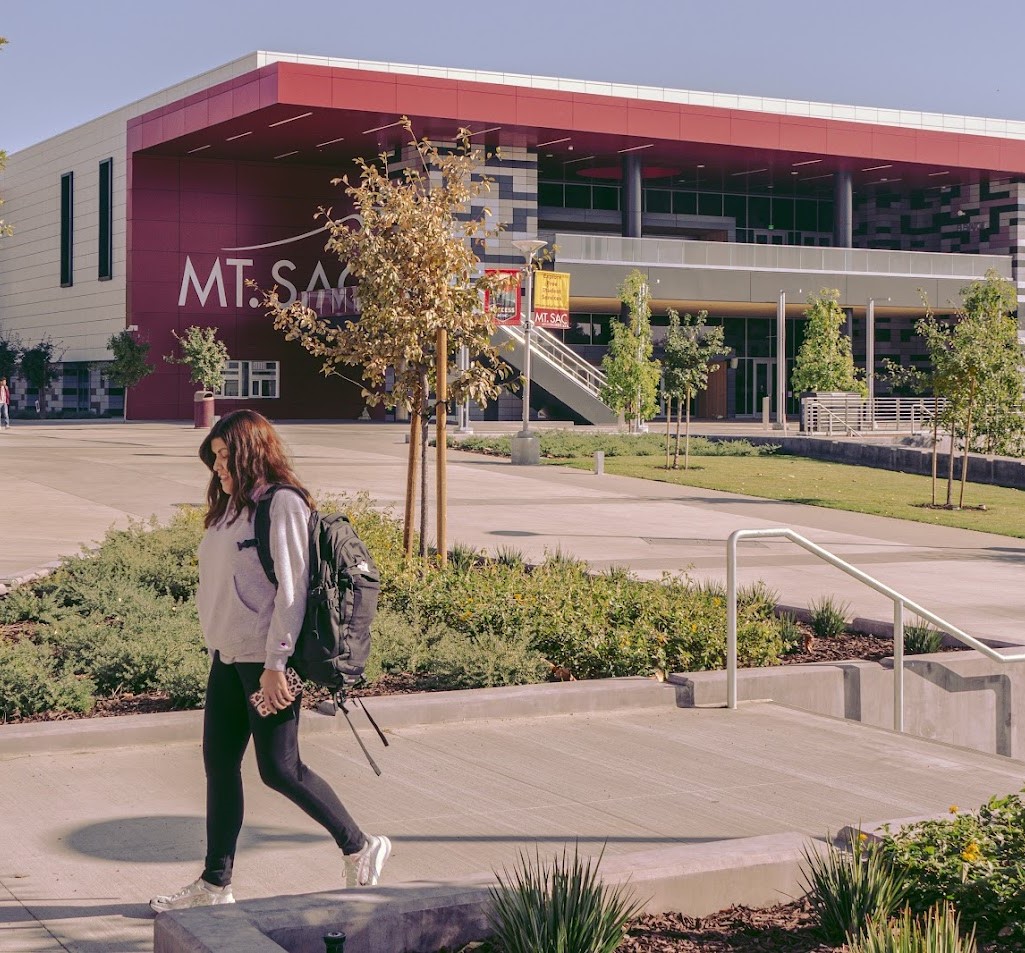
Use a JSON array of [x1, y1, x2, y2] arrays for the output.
[[154, 833, 825, 953]]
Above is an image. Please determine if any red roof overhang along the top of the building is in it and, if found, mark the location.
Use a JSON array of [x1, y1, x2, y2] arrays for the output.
[[128, 60, 1025, 195]]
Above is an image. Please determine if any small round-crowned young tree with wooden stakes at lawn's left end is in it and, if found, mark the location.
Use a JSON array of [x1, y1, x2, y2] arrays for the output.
[[662, 308, 725, 470]]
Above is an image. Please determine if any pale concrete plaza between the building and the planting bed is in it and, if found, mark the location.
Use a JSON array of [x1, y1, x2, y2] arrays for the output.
[[0, 423, 1025, 640]]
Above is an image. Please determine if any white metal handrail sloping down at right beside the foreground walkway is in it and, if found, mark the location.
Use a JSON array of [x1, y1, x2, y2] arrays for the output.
[[726, 527, 1025, 732]]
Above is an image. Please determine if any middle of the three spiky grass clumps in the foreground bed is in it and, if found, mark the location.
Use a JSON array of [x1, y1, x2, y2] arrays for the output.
[[802, 833, 906, 945]]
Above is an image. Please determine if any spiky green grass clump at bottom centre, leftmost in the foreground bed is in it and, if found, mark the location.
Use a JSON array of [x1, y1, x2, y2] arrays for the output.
[[488, 848, 642, 953]]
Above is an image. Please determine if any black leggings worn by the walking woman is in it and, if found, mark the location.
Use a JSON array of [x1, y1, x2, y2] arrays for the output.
[[203, 653, 366, 886]]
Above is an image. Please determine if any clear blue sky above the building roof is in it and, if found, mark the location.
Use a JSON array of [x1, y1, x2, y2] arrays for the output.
[[0, 0, 1025, 153]]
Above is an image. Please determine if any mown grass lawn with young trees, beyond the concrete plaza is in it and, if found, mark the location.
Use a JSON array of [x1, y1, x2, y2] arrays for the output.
[[550, 454, 1025, 538]]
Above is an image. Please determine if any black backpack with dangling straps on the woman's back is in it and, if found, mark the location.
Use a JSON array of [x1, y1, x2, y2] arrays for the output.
[[250, 484, 387, 775]]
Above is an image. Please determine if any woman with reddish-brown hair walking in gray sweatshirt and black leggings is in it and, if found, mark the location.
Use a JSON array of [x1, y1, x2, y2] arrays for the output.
[[150, 410, 392, 913]]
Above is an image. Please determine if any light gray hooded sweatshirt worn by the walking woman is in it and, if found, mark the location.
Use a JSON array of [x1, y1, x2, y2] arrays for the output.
[[196, 493, 310, 671]]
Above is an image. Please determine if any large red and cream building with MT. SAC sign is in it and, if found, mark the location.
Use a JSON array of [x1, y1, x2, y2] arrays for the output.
[[0, 52, 1025, 420]]
